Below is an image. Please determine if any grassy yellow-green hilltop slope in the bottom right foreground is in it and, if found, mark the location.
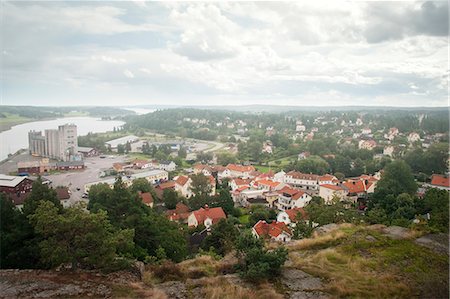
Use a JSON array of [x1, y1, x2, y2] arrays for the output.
[[288, 225, 448, 298]]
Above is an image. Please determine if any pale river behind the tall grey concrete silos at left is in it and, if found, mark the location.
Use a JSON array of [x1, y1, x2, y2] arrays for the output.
[[0, 117, 125, 161]]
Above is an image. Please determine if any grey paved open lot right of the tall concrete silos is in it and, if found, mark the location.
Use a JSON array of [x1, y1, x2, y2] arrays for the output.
[[45, 156, 126, 203]]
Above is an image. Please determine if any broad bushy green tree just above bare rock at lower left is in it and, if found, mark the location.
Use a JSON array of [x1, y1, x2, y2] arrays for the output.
[[29, 201, 133, 269]]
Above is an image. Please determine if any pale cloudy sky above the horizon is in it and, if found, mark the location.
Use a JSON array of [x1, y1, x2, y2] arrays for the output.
[[0, 1, 449, 107]]
